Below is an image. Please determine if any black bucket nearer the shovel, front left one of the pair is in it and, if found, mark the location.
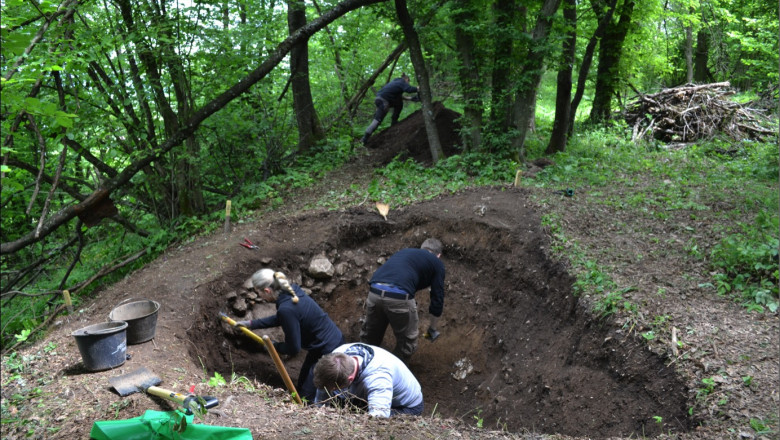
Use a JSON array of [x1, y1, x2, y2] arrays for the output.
[[72, 321, 127, 371]]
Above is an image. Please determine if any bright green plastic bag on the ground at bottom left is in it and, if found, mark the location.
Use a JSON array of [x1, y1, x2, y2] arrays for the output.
[[89, 410, 252, 440]]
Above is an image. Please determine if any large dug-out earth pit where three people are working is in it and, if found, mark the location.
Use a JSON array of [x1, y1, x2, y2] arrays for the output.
[[188, 187, 694, 438]]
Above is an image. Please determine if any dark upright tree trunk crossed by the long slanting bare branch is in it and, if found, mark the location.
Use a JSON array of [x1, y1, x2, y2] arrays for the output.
[[287, 0, 324, 152]]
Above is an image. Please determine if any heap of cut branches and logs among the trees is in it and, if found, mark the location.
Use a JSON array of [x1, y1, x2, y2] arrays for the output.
[[622, 82, 777, 143]]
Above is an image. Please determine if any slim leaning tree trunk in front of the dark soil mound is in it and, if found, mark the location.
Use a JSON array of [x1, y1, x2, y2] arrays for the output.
[[395, 0, 444, 163]]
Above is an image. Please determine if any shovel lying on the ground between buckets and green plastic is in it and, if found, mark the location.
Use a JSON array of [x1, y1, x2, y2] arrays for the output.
[[108, 367, 219, 414]]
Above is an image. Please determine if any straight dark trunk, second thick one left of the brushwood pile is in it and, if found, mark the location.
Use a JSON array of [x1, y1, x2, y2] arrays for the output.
[[544, 0, 577, 155]]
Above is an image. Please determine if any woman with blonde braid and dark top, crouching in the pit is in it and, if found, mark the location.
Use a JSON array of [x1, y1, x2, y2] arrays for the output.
[[236, 269, 345, 402]]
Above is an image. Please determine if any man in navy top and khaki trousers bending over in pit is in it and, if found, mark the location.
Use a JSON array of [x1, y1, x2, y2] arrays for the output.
[[360, 238, 445, 362]]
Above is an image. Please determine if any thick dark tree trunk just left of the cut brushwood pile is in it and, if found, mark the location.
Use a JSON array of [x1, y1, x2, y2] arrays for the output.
[[589, 0, 634, 124]]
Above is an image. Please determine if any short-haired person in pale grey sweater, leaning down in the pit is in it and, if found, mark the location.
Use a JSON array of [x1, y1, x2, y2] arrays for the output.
[[314, 343, 424, 417]]
